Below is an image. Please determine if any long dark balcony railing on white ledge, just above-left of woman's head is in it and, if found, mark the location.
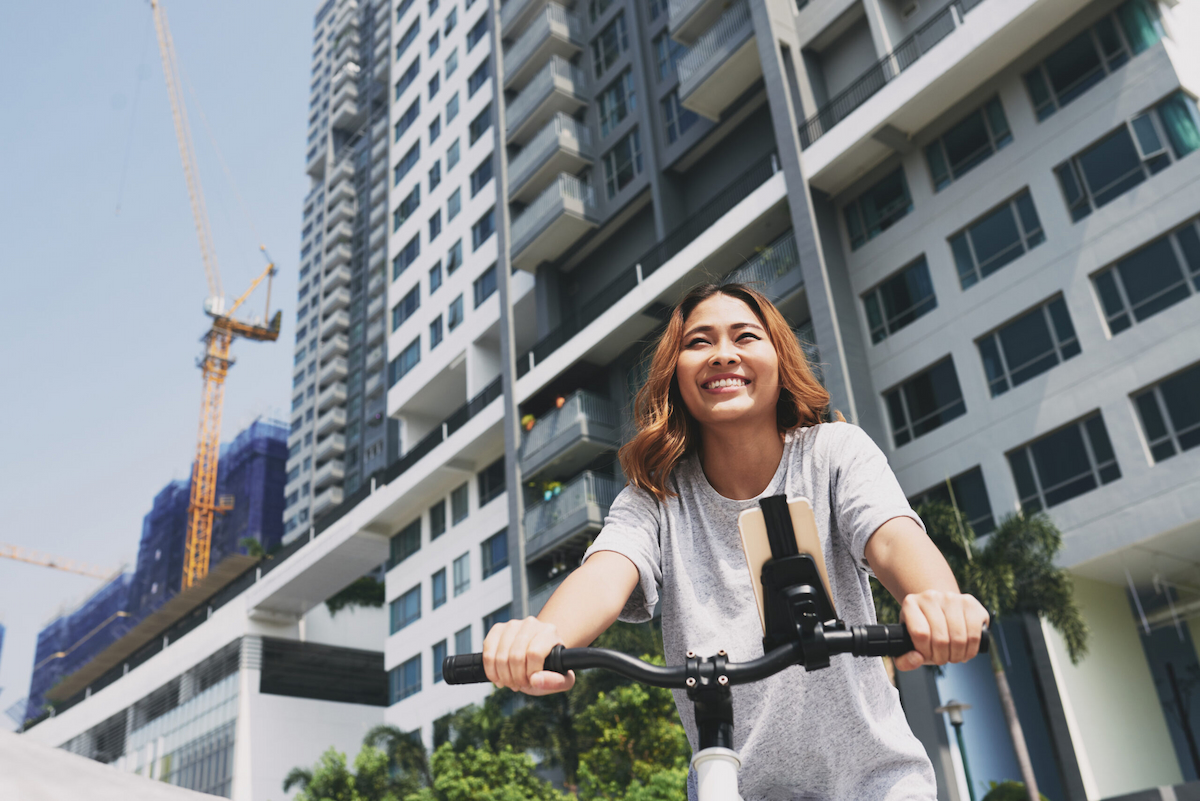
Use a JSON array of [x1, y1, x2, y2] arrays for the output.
[[517, 153, 779, 378]]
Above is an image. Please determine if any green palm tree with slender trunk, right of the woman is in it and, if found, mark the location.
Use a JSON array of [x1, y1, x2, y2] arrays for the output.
[[875, 501, 1087, 801]]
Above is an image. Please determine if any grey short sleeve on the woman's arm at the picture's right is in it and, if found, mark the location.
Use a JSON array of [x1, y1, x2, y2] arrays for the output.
[[822, 423, 925, 573]]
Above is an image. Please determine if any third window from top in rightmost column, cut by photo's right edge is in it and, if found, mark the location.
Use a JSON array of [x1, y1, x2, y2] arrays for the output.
[[1092, 214, 1200, 335]]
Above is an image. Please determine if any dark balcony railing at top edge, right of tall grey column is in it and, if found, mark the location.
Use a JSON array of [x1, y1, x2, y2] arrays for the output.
[[800, 0, 983, 147]]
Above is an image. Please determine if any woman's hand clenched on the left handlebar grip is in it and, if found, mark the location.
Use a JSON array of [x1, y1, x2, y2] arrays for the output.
[[484, 618, 575, 695]]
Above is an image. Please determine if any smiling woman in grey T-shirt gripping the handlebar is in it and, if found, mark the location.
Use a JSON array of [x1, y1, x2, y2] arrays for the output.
[[484, 284, 988, 801]]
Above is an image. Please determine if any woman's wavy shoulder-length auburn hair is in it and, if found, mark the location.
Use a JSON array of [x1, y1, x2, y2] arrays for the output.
[[619, 284, 841, 501]]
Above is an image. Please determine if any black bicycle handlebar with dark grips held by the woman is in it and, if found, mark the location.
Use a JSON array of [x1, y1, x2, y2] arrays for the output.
[[442, 624, 990, 689]]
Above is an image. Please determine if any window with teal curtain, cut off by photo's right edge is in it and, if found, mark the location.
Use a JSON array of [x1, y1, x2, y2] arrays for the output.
[[1055, 92, 1200, 222]]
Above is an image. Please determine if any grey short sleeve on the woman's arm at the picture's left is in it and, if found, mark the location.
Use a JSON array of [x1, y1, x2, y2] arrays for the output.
[[583, 484, 662, 624]]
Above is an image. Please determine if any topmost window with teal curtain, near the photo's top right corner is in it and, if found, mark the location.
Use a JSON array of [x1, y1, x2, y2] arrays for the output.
[[1025, 0, 1164, 121]]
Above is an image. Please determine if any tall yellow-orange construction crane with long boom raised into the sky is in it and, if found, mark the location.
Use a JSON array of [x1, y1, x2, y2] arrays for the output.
[[150, 0, 282, 590]]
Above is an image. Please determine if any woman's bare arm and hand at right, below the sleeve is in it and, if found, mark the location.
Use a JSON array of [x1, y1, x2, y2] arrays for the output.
[[865, 517, 988, 670]]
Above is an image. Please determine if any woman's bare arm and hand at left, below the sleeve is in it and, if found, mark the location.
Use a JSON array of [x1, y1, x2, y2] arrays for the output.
[[484, 550, 638, 695]]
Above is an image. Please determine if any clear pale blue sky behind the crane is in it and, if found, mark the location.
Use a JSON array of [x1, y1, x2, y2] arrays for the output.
[[0, 0, 316, 728]]
